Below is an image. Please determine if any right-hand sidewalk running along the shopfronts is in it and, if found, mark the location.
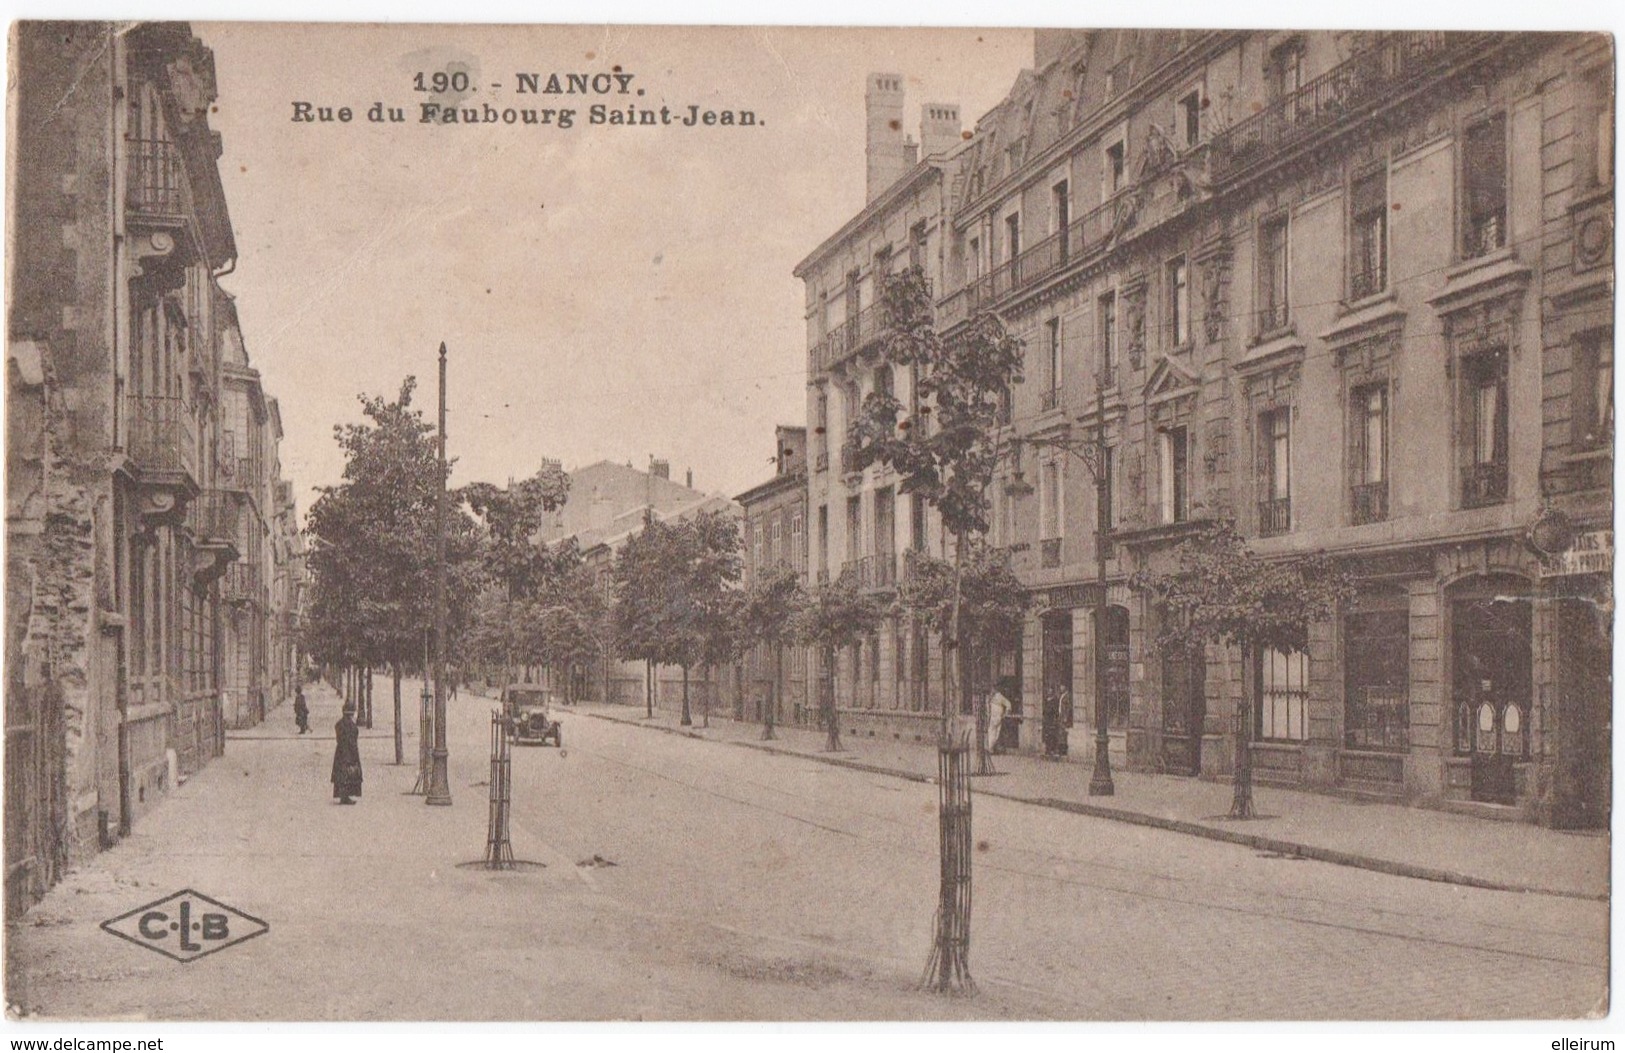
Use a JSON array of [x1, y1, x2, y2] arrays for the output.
[[572, 704, 1610, 902]]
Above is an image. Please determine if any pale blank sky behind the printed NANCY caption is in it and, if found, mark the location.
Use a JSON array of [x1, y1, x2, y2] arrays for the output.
[[193, 23, 1032, 510]]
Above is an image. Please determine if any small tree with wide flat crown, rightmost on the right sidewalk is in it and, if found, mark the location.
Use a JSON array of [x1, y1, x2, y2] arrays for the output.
[[1129, 522, 1354, 819]]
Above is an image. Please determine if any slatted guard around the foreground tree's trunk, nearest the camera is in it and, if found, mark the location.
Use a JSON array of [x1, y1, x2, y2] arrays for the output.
[[921, 738, 977, 995]]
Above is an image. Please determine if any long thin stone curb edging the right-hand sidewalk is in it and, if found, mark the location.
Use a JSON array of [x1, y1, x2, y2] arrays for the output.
[[582, 713, 1609, 904]]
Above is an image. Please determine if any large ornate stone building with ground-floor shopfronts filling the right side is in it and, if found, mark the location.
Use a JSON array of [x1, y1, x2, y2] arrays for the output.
[[803, 29, 1614, 826]]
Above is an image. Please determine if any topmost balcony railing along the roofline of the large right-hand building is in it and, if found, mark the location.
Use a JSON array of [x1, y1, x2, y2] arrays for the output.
[[1207, 31, 1489, 182]]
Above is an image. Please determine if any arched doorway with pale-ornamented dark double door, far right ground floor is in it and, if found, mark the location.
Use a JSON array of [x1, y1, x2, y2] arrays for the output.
[[1451, 595, 1534, 804]]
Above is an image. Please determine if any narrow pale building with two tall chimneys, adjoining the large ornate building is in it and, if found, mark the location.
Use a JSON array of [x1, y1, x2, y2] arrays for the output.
[[795, 73, 965, 741]]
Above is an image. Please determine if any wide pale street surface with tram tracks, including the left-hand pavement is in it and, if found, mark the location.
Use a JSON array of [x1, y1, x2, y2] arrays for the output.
[[7, 686, 1607, 1019]]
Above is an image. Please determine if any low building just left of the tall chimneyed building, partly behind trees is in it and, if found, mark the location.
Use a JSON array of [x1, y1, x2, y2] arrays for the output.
[[733, 424, 812, 723]]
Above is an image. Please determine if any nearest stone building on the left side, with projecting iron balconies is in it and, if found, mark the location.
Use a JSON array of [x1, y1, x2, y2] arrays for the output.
[[5, 23, 305, 912]]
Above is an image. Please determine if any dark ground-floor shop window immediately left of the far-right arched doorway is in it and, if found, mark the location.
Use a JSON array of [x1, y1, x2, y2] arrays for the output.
[[1342, 593, 1411, 752]]
